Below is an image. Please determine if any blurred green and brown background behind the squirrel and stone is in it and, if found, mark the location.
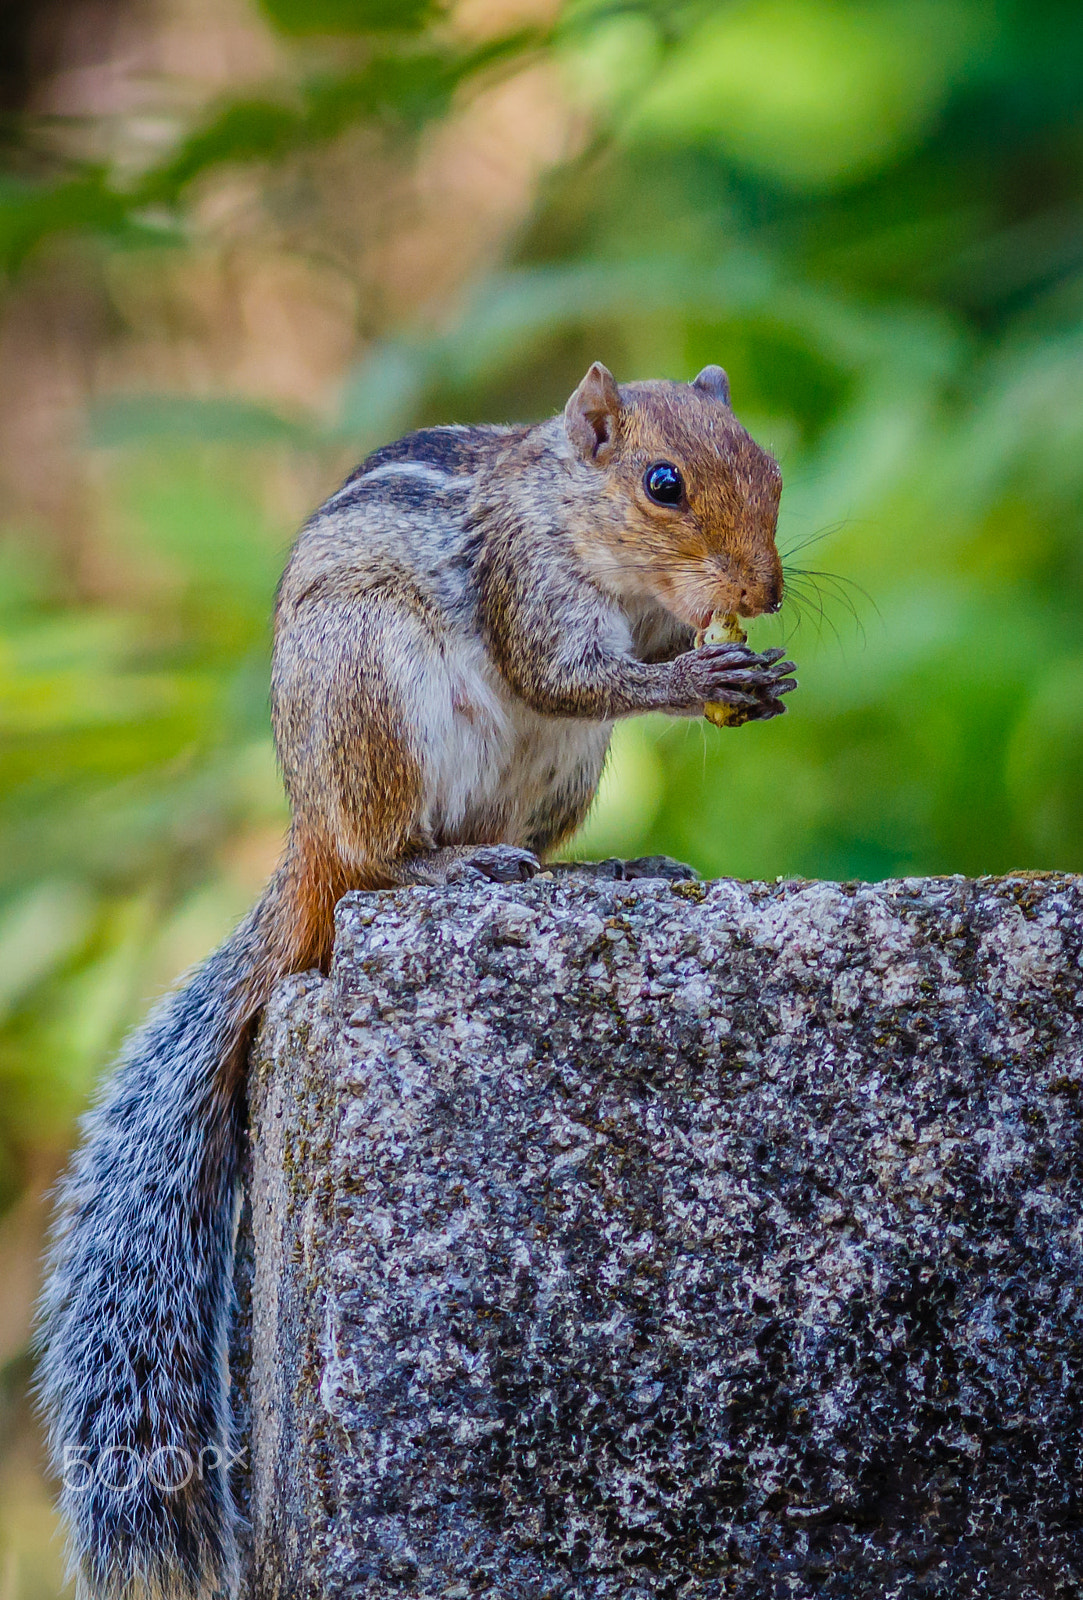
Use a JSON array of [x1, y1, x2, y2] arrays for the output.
[[0, 0, 1083, 1600]]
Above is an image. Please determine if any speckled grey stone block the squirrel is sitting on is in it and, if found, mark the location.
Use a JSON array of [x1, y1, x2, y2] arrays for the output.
[[240, 874, 1083, 1600]]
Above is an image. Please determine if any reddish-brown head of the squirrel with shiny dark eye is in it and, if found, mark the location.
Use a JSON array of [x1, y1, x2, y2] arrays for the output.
[[565, 362, 782, 627]]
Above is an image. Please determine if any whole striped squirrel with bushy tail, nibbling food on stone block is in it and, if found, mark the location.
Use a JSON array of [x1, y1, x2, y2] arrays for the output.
[[38, 362, 795, 1600]]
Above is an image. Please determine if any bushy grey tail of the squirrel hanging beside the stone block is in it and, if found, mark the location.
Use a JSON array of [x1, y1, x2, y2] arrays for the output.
[[38, 858, 329, 1600]]
